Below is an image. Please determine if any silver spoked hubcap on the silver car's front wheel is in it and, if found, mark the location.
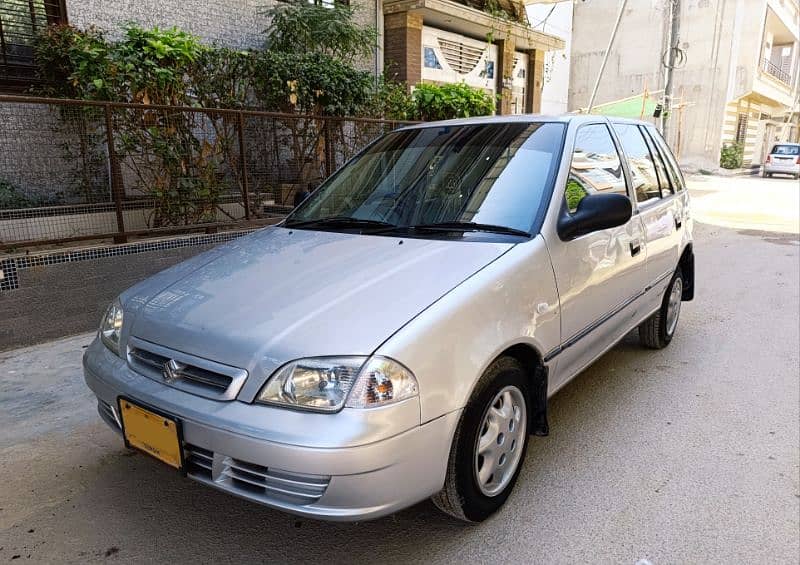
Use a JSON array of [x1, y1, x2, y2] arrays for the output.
[[475, 386, 528, 496]]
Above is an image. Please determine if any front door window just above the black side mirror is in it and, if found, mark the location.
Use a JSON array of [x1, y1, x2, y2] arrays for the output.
[[564, 124, 628, 213]]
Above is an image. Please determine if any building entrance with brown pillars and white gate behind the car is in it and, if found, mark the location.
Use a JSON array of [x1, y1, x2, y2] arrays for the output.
[[383, 0, 564, 114]]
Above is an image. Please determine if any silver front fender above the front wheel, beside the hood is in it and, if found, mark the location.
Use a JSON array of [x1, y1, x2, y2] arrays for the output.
[[376, 236, 561, 422]]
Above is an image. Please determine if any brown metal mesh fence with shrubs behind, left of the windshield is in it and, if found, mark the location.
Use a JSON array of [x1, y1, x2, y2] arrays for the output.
[[0, 96, 412, 249]]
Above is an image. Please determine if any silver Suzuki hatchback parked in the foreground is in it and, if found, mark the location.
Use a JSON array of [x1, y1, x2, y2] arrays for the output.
[[84, 116, 694, 522]]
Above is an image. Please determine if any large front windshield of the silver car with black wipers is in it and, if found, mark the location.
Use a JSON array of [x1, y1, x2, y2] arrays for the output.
[[286, 122, 565, 237]]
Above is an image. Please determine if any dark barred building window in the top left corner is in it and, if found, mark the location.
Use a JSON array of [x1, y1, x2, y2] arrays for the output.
[[0, 0, 66, 90]]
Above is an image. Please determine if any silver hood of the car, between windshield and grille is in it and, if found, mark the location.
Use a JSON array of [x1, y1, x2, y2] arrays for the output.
[[123, 227, 512, 388]]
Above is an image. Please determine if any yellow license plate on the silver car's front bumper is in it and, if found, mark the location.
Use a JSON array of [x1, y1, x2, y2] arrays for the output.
[[119, 398, 183, 469]]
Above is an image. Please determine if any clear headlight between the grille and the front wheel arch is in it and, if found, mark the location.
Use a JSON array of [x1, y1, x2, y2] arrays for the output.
[[256, 357, 418, 412]]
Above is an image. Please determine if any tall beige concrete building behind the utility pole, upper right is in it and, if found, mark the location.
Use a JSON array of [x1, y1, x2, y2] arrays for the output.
[[569, 0, 800, 169]]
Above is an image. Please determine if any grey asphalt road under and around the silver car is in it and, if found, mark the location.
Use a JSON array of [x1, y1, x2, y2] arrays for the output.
[[0, 174, 800, 564]]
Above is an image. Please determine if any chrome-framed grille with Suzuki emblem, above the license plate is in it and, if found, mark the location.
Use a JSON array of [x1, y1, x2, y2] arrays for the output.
[[128, 337, 247, 400]]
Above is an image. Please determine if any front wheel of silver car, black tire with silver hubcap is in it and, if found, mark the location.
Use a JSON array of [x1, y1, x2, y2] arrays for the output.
[[432, 357, 530, 523]]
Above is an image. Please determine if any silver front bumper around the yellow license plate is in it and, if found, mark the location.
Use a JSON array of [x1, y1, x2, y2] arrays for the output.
[[84, 341, 460, 521]]
